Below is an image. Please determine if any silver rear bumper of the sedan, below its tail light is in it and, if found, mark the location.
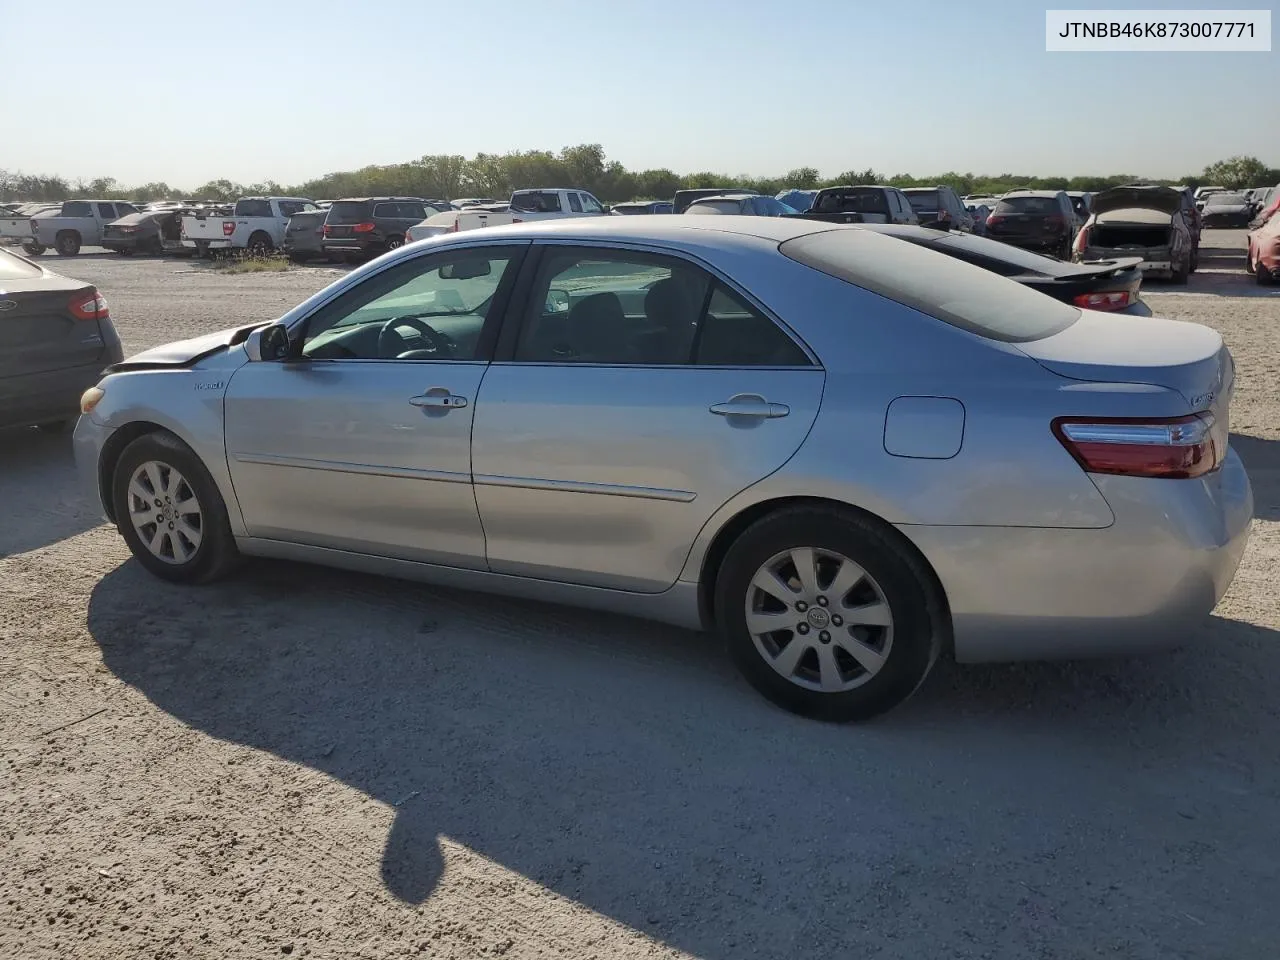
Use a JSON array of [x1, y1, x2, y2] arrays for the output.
[[900, 451, 1253, 663]]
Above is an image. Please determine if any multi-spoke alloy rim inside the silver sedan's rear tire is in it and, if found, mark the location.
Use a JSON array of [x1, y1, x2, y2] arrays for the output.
[[746, 547, 893, 694]]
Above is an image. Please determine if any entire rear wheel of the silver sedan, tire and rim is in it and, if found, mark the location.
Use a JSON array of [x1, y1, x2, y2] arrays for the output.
[[716, 507, 941, 721]]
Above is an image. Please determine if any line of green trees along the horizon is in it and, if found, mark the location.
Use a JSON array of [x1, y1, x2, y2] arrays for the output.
[[0, 143, 1280, 204]]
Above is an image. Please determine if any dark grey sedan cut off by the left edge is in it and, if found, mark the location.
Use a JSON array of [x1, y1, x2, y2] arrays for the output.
[[0, 250, 124, 431]]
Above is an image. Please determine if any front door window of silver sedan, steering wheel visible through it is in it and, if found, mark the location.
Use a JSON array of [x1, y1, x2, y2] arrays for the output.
[[302, 251, 511, 360]]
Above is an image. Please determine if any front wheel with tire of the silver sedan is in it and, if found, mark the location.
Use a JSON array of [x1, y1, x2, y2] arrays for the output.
[[111, 433, 239, 584]]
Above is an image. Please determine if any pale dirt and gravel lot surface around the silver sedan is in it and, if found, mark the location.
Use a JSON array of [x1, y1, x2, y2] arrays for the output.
[[0, 230, 1280, 960]]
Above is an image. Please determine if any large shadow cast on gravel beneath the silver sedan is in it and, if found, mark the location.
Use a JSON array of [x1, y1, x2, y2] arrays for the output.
[[88, 561, 1280, 960]]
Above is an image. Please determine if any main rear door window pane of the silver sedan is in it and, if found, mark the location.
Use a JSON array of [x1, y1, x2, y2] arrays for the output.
[[516, 250, 710, 364]]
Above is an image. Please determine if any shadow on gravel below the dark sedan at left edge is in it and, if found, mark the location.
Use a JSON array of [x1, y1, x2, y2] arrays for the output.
[[0, 428, 102, 557]]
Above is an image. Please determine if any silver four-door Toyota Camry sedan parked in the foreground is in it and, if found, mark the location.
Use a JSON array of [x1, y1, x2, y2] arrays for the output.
[[76, 216, 1253, 719]]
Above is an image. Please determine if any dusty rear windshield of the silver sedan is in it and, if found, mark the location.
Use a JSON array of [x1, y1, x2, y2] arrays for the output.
[[780, 229, 1080, 343]]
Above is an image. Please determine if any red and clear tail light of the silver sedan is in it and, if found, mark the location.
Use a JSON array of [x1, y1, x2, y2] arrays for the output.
[[1052, 413, 1226, 480]]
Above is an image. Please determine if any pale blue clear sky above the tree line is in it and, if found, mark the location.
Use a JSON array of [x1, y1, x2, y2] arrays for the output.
[[0, 0, 1280, 187]]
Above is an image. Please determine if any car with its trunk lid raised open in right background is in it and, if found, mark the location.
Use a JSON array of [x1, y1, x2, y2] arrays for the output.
[[1071, 187, 1199, 284]]
